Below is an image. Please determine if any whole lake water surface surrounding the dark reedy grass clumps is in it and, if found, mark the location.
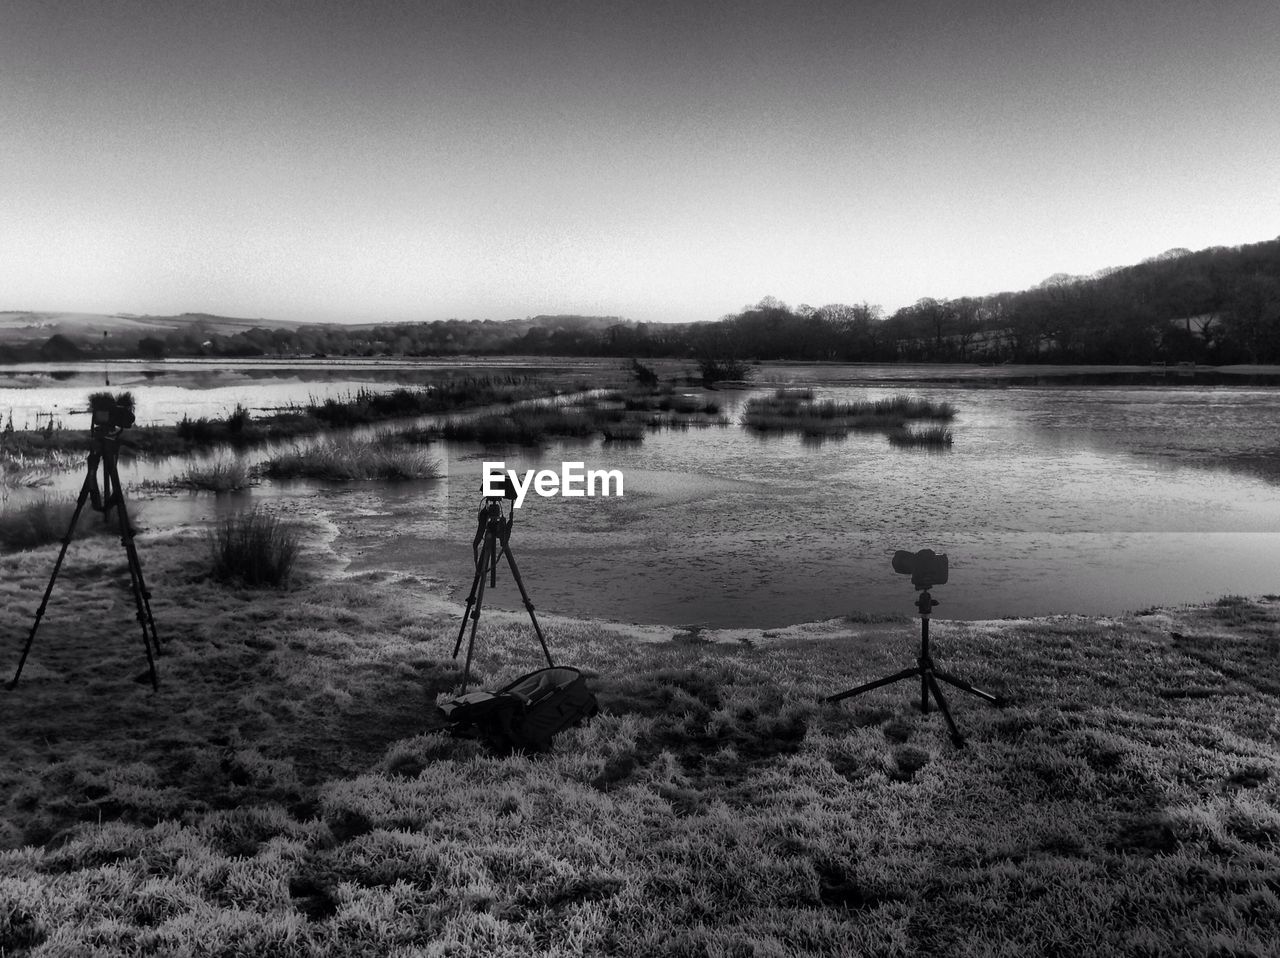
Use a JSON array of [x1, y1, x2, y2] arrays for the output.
[[0, 360, 1280, 628]]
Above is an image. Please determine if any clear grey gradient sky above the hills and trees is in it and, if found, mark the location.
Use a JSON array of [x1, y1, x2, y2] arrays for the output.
[[0, 0, 1280, 323]]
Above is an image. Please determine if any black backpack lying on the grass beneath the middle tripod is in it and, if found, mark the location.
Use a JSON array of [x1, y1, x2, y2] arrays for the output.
[[440, 666, 599, 753]]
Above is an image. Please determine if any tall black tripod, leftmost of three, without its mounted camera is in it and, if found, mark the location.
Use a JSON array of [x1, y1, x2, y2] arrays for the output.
[[9, 418, 160, 690]]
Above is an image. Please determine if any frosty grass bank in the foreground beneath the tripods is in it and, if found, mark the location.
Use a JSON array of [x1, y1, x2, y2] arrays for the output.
[[0, 519, 1280, 958]]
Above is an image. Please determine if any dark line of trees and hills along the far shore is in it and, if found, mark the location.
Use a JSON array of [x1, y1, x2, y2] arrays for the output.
[[10, 238, 1280, 365]]
